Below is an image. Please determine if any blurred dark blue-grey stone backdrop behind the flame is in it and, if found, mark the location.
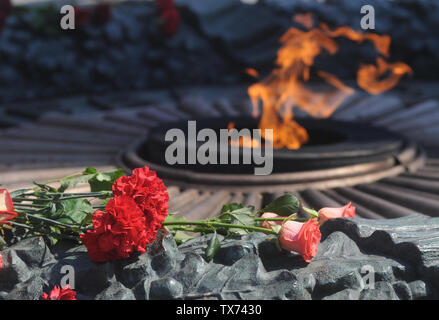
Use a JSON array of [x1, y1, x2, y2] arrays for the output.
[[0, 0, 439, 103]]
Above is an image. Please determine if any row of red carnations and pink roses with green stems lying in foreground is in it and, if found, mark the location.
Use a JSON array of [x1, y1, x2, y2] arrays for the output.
[[0, 167, 355, 262]]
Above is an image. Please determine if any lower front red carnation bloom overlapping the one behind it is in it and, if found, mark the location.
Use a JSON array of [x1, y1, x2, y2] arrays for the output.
[[81, 195, 156, 262]]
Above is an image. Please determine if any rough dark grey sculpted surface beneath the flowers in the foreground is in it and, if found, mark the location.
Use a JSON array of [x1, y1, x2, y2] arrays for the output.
[[0, 215, 439, 299]]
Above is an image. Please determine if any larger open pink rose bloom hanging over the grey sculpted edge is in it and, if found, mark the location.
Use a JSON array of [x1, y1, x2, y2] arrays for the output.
[[279, 218, 322, 262]]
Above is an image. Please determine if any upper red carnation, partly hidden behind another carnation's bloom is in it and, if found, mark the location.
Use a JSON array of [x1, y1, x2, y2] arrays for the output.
[[113, 167, 169, 242]]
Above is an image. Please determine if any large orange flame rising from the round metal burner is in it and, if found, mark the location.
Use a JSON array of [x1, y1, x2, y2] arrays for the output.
[[248, 14, 412, 149]]
